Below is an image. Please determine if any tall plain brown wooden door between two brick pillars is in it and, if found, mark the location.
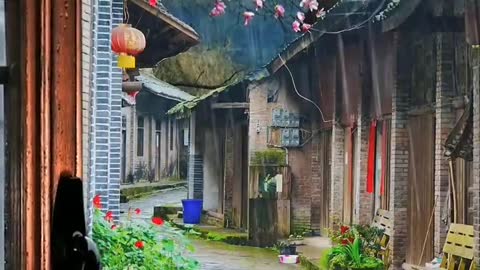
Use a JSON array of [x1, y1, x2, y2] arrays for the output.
[[407, 114, 435, 265]]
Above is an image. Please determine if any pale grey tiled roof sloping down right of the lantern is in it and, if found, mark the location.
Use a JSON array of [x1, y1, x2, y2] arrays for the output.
[[136, 68, 194, 102]]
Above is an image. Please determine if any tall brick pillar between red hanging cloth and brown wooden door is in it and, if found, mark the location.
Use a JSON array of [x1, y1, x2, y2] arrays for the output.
[[390, 34, 410, 269]]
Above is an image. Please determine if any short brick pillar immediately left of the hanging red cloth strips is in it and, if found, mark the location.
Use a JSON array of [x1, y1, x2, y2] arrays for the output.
[[353, 116, 373, 224]]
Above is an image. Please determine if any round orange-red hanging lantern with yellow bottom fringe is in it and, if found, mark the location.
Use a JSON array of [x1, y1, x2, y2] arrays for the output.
[[112, 24, 146, 68]]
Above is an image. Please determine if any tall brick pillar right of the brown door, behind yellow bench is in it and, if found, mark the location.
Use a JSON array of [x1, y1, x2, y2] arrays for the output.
[[434, 33, 455, 255]]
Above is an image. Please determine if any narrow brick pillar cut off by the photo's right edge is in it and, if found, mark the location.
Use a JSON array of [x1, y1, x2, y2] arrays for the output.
[[472, 49, 480, 267]]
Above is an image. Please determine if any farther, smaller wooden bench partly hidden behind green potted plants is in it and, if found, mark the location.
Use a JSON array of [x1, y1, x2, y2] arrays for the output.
[[372, 209, 393, 269]]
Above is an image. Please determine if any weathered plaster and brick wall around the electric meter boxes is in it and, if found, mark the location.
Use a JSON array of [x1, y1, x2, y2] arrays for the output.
[[249, 65, 314, 229]]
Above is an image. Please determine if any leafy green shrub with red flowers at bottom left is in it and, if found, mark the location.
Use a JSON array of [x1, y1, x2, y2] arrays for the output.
[[93, 206, 199, 270]]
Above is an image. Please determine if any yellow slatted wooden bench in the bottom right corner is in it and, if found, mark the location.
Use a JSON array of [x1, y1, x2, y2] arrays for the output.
[[440, 224, 476, 270]]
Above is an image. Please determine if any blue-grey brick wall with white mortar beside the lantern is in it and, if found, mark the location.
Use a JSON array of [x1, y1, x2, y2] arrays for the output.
[[90, 0, 123, 219]]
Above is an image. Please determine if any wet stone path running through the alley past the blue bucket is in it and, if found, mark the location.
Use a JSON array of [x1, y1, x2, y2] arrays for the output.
[[121, 188, 300, 270]]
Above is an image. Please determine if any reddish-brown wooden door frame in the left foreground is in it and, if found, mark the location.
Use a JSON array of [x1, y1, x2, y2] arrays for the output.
[[5, 0, 82, 270]]
